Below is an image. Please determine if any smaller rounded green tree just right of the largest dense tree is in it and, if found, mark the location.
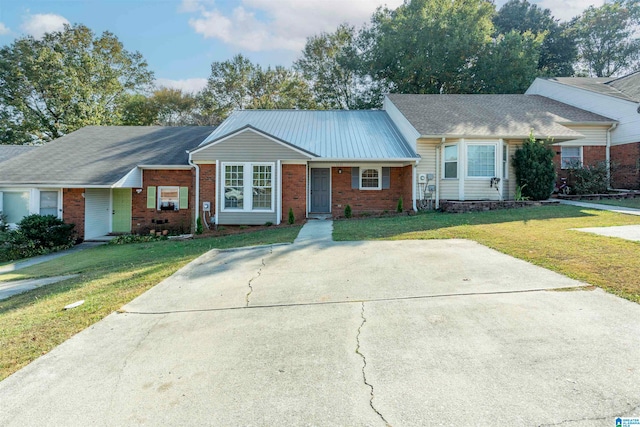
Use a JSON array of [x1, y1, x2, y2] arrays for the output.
[[474, 31, 544, 93]]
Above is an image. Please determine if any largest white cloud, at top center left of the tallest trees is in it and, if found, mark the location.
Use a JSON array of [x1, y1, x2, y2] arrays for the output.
[[181, 0, 402, 51]]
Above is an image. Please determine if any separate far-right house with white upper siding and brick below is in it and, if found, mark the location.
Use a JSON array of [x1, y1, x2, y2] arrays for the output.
[[527, 72, 640, 189]]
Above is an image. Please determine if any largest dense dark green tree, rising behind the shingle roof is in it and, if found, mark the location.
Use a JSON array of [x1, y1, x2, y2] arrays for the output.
[[364, 0, 495, 93]]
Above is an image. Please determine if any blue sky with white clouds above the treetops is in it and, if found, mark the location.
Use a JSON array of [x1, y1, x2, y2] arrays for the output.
[[0, 0, 603, 90]]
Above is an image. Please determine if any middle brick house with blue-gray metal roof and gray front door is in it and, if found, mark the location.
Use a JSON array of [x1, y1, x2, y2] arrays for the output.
[[189, 110, 419, 225]]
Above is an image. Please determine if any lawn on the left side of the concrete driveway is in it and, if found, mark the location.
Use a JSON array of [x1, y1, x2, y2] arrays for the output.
[[0, 227, 300, 380]]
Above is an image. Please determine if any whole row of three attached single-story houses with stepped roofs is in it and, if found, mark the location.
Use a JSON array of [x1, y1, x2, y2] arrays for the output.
[[0, 95, 617, 239]]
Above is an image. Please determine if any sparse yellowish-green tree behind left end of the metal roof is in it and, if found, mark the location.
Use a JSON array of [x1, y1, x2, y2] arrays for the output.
[[197, 55, 315, 123]]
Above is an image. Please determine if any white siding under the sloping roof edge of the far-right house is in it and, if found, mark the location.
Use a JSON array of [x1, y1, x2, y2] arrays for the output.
[[526, 78, 640, 145]]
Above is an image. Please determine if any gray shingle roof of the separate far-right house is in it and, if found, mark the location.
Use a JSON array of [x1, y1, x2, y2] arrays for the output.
[[549, 71, 640, 102]]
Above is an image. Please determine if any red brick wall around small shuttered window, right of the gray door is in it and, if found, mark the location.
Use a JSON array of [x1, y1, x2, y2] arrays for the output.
[[331, 166, 413, 216]]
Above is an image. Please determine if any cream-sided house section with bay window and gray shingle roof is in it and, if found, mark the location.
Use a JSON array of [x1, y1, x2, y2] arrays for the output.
[[384, 94, 615, 206]]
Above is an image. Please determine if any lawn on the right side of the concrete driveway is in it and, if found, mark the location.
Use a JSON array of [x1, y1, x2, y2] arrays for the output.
[[333, 206, 640, 303]]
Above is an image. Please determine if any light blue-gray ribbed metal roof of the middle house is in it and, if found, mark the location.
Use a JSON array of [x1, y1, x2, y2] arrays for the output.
[[200, 110, 418, 160]]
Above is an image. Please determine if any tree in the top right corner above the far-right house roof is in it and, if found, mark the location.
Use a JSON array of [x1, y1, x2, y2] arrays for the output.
[[575, 0, 640, 77]]
